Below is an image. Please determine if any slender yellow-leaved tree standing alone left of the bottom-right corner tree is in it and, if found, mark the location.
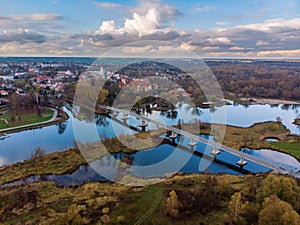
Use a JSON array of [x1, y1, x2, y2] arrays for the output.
[[227, 192, 249, 224]]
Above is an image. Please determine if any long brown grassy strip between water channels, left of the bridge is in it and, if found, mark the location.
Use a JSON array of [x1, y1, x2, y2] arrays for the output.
[[0, 129, 162, 185]]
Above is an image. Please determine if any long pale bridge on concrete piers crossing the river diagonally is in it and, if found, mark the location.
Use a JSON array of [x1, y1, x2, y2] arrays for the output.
[[71, 105, 300, 178]]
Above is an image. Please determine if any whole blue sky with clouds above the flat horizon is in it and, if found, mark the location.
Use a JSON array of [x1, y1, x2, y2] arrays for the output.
[[0, 0, 300, 58]]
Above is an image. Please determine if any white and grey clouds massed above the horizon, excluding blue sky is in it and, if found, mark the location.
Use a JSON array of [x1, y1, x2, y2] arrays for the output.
[[0, 1, 300, 57]]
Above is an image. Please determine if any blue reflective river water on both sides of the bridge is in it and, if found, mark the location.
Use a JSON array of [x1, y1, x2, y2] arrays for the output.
[[0, 103, 300, 179]]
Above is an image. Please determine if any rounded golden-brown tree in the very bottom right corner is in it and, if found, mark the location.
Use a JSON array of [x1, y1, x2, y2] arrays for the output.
[[258, 195, 300, 225]]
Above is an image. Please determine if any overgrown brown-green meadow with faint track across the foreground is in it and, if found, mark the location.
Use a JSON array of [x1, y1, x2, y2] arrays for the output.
[[0, 171, 299, 225]]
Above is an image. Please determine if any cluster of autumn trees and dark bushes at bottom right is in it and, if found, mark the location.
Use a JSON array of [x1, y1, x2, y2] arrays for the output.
[[165, 174, 300, 225]]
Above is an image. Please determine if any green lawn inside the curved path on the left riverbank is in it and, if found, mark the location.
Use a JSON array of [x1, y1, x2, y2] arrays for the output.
[[0, 109, 54, 129]]
